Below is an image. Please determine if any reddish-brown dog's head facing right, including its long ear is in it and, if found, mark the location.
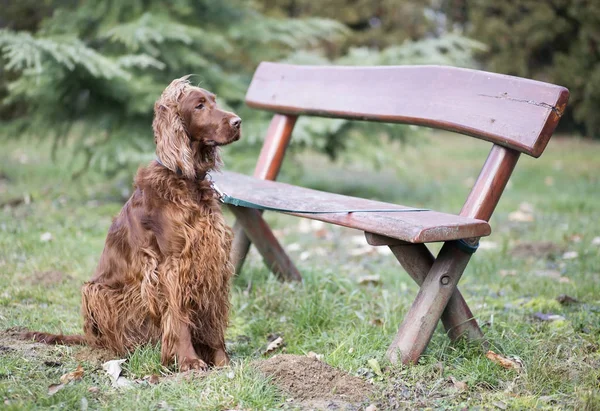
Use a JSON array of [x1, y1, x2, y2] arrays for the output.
[[152, 76, 242, 178]]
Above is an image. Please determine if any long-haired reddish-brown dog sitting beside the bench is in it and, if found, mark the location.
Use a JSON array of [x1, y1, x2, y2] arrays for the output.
[[24, 77, 241, 371]]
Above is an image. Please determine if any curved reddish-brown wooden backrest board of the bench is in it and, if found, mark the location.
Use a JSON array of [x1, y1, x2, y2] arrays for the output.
[[246, 62, 569, 157]]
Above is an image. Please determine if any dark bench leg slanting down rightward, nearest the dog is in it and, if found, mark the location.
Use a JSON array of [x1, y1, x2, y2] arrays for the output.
[[228, 206, 302, 281]]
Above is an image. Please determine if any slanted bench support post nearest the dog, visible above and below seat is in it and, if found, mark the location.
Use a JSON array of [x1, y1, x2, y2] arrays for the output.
[[230, 114, 297, 273]]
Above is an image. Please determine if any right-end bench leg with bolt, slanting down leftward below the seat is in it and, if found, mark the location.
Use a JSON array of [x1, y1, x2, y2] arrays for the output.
[[387, 242, 471, 364]]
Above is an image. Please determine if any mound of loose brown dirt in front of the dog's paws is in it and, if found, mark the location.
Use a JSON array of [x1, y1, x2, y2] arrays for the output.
[[256, 354, 373, 409]]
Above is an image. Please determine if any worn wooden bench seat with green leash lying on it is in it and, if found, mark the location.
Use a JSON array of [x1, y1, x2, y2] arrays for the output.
[[212, 171, 491, 243]]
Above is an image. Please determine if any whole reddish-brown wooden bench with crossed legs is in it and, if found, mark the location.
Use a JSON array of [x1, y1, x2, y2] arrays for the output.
[[214, 63, 569, 364]]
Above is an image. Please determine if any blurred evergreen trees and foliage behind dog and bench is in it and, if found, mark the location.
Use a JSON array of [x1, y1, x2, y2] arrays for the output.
[[0, 0, 600, 174]]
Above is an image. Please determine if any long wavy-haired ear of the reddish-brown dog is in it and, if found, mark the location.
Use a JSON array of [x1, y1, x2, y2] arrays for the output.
[[152, 77, 196, 178]]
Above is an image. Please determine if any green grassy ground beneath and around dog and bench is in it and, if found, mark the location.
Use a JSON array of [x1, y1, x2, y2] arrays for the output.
[[0, 133, 600, 410]]
